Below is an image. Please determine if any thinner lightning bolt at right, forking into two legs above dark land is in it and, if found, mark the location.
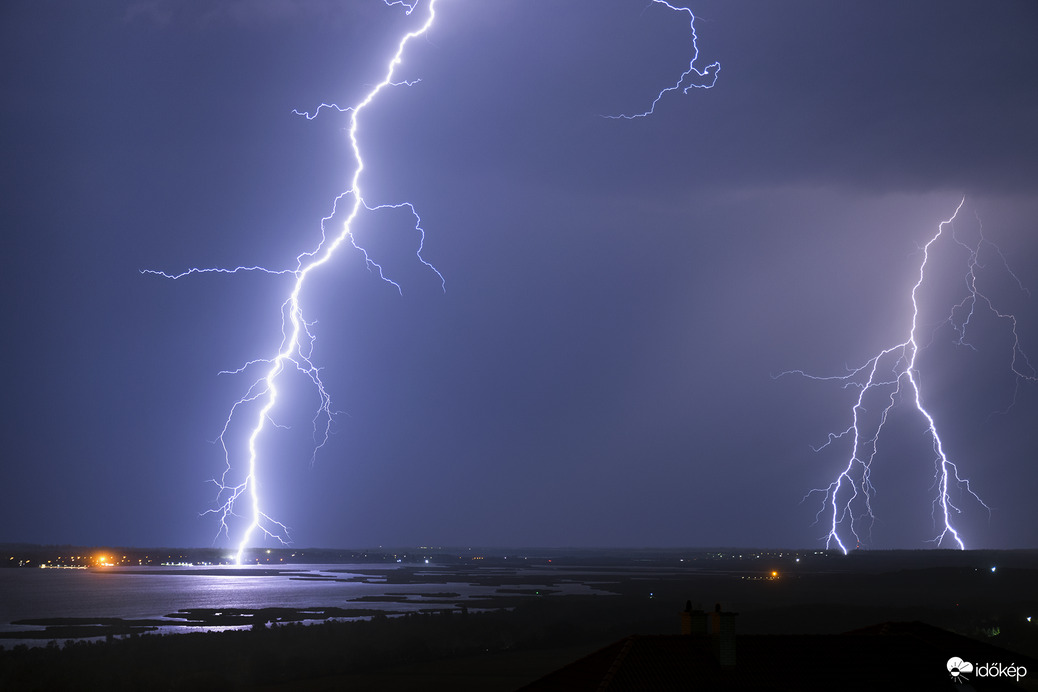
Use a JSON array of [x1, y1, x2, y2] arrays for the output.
[[776, 198, 1038, 554]]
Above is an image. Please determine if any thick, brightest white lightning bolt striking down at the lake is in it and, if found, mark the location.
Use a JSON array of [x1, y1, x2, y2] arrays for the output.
[[142, 0, 444, 564]]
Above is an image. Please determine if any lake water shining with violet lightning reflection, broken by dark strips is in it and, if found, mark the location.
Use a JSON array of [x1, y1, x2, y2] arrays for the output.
[[0, 564, 600, 648]]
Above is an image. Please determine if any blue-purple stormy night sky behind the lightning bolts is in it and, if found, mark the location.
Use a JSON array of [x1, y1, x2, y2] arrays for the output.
[[0, 0, 1038, 548]]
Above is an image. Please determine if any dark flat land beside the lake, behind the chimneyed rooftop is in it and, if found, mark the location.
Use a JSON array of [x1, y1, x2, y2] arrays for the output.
[[0, 549, 1038, 690]]
